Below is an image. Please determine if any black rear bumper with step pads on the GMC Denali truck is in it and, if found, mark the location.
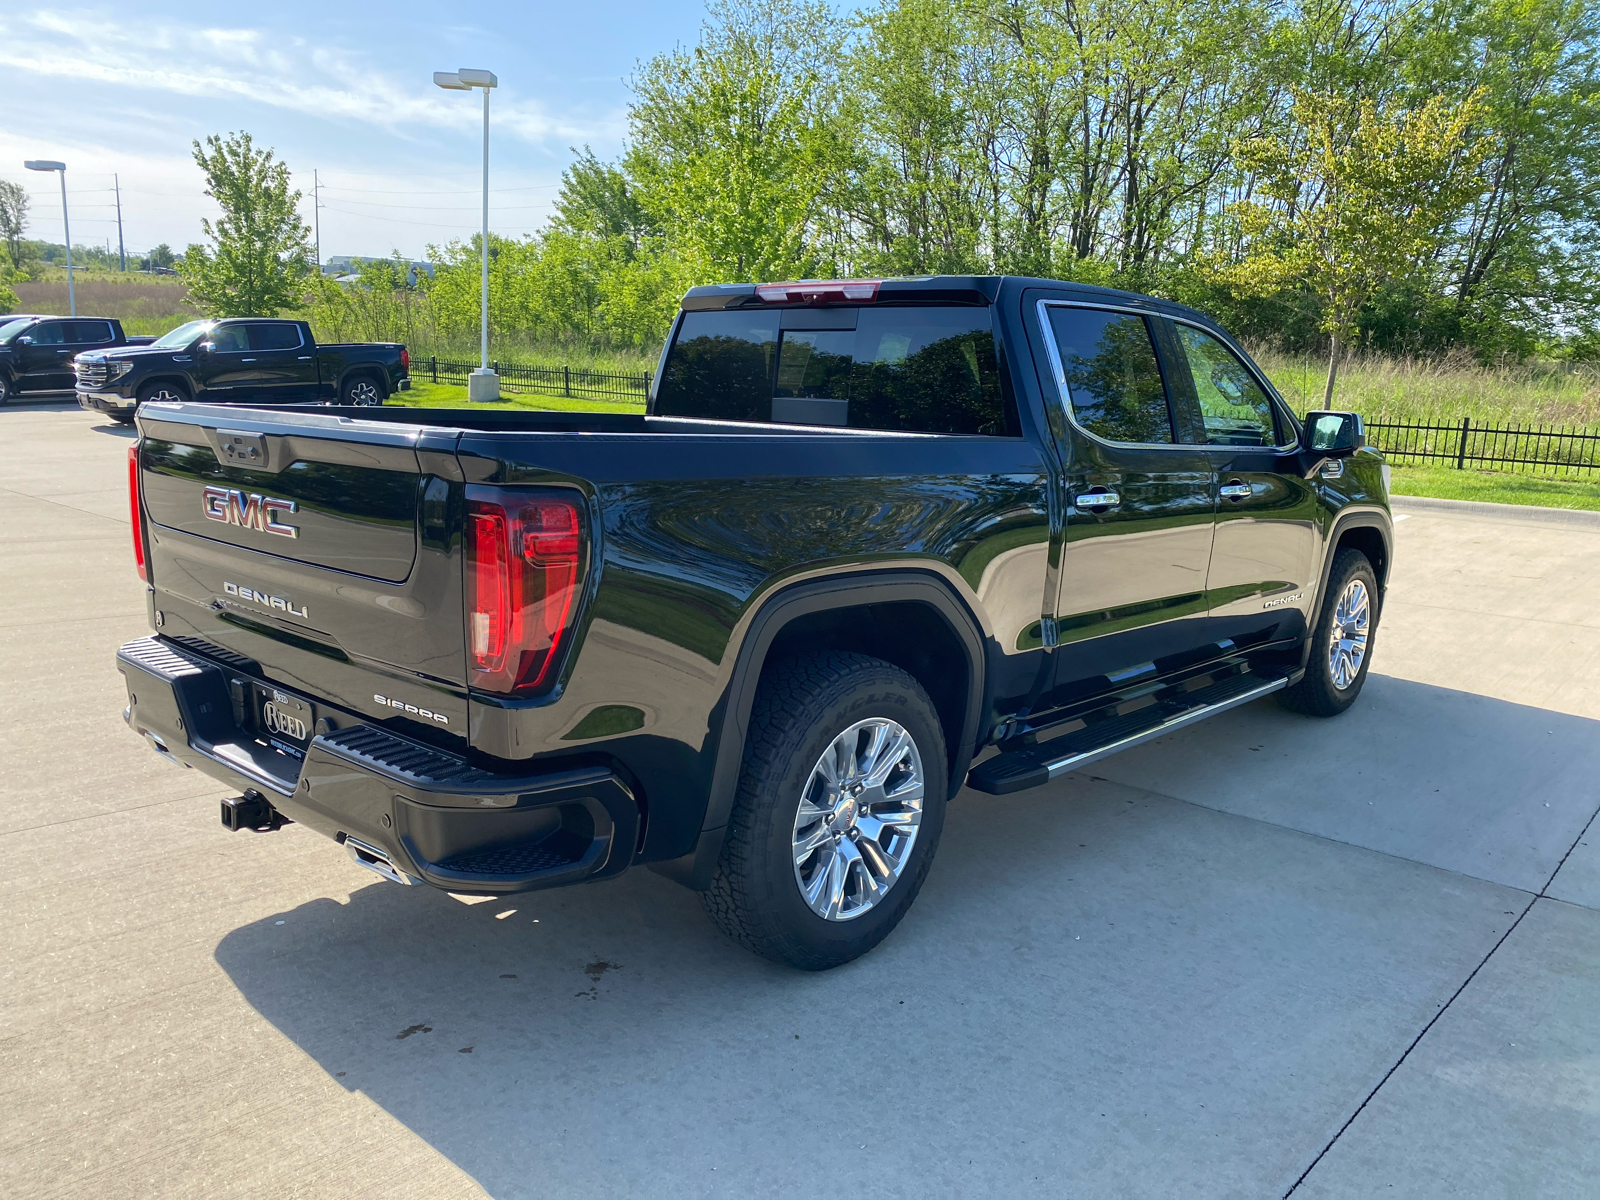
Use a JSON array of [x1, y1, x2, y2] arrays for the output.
[[117, 637, 640, 894]]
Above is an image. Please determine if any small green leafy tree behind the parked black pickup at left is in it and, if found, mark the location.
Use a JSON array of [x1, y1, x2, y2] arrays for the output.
[[179, 133, 312, 317]]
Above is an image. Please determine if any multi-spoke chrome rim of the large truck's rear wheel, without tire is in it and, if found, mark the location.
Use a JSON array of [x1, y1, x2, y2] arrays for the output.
[[794, 717, 923, 922]]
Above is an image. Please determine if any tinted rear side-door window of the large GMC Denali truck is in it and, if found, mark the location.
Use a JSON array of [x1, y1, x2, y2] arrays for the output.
[[1050, 307, 1173, 445]]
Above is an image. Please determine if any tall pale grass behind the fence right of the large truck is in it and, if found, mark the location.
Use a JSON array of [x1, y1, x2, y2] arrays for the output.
[[1251, 347, 1600, 427]]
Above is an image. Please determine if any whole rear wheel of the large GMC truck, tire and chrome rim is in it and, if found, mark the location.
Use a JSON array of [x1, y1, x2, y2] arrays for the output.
[[702, 651, 949, 971]]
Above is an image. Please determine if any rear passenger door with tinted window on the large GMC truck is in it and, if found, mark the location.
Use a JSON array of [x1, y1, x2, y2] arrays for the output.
[[1029, 299, 1216, 701]]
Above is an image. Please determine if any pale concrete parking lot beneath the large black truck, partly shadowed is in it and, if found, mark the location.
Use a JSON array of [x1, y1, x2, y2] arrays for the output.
[[9, 403, 1600, 1200]]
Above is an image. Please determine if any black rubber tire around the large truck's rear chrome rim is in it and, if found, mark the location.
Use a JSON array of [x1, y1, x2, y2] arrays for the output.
[[701, 651, 949, 971]]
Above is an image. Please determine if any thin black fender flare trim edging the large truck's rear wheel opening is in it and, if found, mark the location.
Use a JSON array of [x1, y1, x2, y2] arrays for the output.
[[650, 568, 987, 891]]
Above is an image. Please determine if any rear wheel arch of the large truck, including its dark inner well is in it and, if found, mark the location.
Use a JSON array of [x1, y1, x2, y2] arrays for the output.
[[650, 570, 987, 891]]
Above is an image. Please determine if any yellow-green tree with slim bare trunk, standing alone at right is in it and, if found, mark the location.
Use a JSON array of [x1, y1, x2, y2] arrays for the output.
[[1224, 91, 1493, 405]]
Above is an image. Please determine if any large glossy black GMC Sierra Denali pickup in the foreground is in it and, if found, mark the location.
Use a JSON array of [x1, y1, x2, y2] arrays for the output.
[[118, 277, 1392, 970]]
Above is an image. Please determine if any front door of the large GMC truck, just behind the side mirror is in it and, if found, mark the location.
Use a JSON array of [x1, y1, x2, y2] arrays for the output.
[[1166, 320, 1322, 642]]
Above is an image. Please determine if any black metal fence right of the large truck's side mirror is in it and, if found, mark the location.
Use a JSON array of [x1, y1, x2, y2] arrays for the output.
[[1366, 418, 1600, 475]]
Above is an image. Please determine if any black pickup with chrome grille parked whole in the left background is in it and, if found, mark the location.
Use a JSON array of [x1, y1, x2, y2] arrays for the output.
[[75, 317, 411, 424]]
